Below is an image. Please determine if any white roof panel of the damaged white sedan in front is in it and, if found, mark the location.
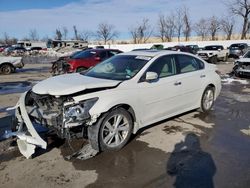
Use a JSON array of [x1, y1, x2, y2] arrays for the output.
[[118, 50, 190, 57]]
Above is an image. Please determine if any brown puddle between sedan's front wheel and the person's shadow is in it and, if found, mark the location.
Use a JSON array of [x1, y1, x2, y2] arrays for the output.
[[62, 140, 171, 187]]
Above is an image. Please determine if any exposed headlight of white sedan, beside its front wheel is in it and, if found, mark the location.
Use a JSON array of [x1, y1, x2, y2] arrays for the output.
[[64, 98, 98, 124]]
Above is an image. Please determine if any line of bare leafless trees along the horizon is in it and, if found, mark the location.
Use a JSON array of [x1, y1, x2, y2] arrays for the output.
[[0, 0, 250, 44]]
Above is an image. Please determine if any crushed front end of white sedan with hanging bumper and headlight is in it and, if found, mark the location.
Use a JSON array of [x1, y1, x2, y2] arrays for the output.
[[11, 91, 98, 158]]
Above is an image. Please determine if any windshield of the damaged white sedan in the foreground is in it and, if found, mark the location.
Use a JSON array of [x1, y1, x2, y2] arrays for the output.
[[84, 55, 151, 80]]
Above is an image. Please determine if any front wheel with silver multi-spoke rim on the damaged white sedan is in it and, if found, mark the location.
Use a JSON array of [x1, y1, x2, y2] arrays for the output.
[[98, 108, 133, 151]]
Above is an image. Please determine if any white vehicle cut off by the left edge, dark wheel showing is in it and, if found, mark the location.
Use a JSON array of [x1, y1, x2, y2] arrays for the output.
[[0, 56, 24, 74]]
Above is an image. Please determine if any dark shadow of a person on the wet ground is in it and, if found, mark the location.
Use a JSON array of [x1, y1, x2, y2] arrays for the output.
[[166, 133, 216, 188]]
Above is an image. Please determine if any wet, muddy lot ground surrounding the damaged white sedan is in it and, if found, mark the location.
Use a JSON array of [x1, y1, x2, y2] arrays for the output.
[[0, 63, 250, 188]]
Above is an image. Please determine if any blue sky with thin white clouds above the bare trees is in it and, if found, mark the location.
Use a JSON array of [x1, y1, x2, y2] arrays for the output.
[[0, 0, 233, 39]]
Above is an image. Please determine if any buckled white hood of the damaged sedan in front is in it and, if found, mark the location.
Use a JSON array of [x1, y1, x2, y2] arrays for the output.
[[32, 73, 121, 96]]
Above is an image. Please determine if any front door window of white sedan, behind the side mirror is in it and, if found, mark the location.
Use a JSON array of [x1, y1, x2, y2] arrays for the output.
[[147, 55, 177, 78]]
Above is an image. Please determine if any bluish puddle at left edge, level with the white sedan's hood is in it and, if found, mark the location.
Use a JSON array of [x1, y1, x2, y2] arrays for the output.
[[0, 81, 32, 95]]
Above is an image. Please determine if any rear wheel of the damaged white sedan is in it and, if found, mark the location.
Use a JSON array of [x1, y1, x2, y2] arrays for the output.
[[200, 86, 214, 113]]
